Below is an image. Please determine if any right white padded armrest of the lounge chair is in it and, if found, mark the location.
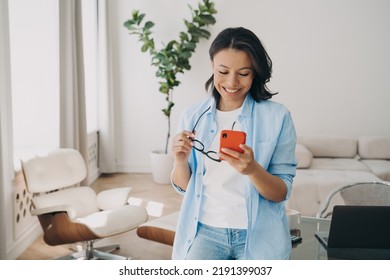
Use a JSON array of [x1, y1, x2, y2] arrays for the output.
[[97, 187, 133, 210]]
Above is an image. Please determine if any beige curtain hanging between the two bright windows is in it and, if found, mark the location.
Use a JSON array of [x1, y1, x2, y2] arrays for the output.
[[59, 0, 88, 175]]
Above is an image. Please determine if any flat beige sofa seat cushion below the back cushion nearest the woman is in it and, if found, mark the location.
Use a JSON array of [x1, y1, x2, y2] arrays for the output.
[[310, 158, 371, 172]]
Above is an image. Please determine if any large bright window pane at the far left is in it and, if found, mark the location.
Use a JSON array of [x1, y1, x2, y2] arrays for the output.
[[8, 0, 60, 165]]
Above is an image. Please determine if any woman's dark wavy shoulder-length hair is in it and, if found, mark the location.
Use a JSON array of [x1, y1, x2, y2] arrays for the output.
[[205, 27, 277, 101]]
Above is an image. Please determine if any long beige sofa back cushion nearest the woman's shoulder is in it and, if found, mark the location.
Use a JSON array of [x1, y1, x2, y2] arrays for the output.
[[298, 135, 357, 158]]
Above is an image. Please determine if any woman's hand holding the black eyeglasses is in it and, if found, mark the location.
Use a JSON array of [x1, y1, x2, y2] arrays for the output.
[[172, 130, 195, 164]]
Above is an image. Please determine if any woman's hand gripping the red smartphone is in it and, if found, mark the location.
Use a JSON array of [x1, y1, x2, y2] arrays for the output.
[[219, 144, 258, 175]]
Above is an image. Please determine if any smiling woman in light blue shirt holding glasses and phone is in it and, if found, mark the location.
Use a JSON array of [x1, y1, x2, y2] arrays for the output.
[[172, 27, 296, 260]]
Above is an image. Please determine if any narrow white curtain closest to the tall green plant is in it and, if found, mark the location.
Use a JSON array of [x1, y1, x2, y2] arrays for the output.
[[97, 0, 116, 173]]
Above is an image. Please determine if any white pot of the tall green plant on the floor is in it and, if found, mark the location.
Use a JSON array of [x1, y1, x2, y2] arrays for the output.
[[150, 151, 173, 184]]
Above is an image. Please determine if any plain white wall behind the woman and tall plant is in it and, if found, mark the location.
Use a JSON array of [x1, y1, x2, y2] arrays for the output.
[[109, 0, 390, 172]]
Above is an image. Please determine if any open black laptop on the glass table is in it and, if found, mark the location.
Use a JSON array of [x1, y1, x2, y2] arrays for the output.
[[315, 205, 390, 260]]
